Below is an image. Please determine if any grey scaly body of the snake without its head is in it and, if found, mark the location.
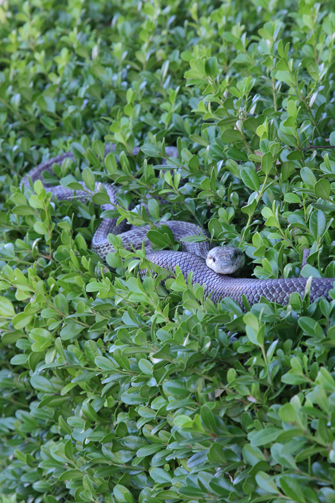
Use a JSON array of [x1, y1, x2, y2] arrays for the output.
[[21, 146, 334, 306]]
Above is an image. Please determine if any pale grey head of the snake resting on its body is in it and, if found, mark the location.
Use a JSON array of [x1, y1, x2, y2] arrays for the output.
[[206, 246, 245, 274]]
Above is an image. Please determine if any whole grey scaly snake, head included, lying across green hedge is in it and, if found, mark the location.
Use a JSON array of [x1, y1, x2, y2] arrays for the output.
[[20, 144, 334, 308]]
